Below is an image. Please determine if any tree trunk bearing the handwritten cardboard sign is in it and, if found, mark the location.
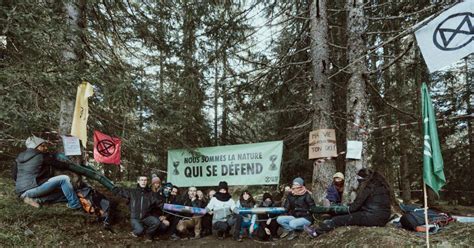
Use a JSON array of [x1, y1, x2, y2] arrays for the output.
[[310, 0, 336, 204]]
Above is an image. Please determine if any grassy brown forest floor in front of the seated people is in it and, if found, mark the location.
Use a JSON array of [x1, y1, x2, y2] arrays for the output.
[[0, 177, 474, 248]]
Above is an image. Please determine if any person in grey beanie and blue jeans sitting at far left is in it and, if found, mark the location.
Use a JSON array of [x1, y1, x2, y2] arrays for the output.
[[12, 136, 82, 209]]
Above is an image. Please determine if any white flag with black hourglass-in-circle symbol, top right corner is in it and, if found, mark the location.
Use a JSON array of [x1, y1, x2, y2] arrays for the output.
[[415, 0, 474, 72]]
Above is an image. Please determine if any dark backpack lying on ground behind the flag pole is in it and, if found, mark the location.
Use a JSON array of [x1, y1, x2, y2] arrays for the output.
[[400, 205, 454, 231]]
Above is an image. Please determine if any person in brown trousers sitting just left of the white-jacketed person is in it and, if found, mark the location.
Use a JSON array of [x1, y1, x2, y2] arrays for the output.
[[176, 187, 206, 239]]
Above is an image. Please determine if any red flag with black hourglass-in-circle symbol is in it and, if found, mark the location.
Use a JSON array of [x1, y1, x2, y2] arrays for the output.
[[94, 131, 122, 165]]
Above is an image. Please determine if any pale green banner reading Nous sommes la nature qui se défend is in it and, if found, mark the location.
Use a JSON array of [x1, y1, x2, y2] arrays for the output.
[[167, 141, 283, 187]]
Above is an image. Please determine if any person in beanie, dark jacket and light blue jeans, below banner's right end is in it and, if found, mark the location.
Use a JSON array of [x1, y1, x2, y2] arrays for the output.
[[277, 177, 315, 240]]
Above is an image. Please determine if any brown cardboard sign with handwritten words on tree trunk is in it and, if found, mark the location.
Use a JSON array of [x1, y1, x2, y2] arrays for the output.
[[309, 129, 337, 159]]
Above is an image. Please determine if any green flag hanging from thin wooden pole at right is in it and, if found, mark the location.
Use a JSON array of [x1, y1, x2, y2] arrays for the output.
[[421, 83, 446, 195]]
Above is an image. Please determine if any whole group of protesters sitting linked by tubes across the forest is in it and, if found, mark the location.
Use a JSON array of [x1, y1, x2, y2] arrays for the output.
[[13, 136, 391, 241]]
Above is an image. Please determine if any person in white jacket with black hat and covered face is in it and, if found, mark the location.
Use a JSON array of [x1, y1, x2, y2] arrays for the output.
[[206, 181, 238, 239]]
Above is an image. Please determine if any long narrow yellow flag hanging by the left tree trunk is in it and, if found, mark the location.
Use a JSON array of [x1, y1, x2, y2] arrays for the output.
[[71, 82, 94, 148]]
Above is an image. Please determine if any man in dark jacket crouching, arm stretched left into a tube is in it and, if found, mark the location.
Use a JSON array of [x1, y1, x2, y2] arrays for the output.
[[112, 176, 161, 241]]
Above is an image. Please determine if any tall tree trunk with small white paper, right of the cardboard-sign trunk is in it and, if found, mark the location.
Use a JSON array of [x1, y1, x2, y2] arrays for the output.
[[343, 0, 367, 203]]
